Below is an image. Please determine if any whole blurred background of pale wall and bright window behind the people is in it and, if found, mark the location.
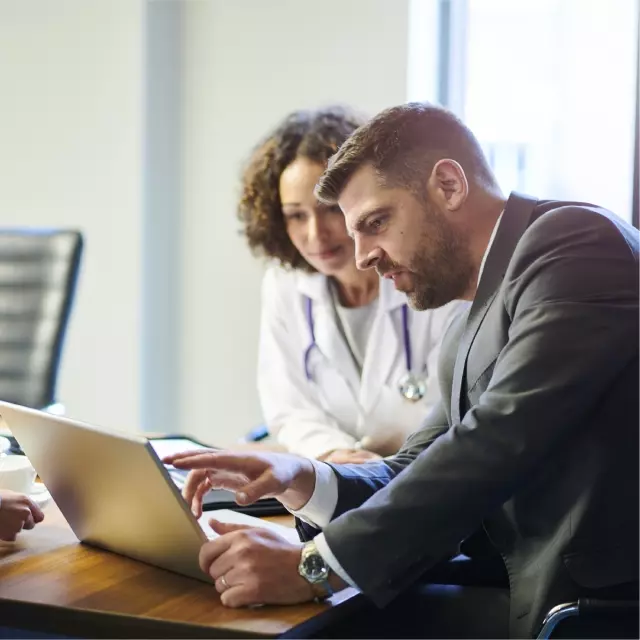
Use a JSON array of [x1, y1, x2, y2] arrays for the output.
[[0, 0, 639, 445]]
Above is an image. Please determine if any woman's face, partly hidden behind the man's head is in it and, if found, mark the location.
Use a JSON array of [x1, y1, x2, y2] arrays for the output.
[[280, 158, 355, 276]]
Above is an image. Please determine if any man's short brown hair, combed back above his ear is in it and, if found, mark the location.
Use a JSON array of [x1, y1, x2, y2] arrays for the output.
[[315, 102, 497, 204]]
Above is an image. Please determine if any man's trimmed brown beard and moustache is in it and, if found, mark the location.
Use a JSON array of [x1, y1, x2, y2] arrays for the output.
[[377, 205, 473, 311]]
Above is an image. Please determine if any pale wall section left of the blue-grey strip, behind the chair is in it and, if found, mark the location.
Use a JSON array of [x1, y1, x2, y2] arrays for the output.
[[0, 0, 143, 428]]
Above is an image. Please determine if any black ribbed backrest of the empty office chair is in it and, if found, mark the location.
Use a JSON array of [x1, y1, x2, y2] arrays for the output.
[[0, 228, 83, 409]]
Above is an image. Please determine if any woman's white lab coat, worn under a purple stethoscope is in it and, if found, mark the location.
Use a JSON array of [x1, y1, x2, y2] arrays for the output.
[[258, 267, 460, 457]]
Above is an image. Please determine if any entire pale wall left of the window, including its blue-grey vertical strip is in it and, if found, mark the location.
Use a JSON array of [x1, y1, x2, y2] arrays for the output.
[[0, 0, 416, 444]]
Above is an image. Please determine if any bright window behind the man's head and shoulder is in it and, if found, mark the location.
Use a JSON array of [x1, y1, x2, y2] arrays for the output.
[[409, 0, 640, 221]]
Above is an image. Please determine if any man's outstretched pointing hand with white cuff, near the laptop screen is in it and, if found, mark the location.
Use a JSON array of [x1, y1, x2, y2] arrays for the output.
[[163, 449, 315, 518]]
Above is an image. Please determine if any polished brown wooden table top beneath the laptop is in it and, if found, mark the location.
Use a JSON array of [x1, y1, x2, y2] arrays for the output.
[[0, 502, 361, 638]]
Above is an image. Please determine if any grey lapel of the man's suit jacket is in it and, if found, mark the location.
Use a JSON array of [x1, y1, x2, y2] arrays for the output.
[[451, 192, 537, 424]]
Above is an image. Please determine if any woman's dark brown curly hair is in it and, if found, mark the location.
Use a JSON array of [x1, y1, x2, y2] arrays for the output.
[[238, 106, 365, 272]]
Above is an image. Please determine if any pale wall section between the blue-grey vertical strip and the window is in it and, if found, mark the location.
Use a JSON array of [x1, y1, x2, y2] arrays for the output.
[[180, 0, 408, 444]]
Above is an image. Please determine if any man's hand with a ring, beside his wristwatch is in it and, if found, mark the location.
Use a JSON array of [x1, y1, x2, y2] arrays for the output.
[[200, 519, 314, 607]]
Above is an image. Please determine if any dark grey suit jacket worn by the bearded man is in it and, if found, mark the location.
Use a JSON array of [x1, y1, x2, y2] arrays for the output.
[[299, 194, 639, 637]]
